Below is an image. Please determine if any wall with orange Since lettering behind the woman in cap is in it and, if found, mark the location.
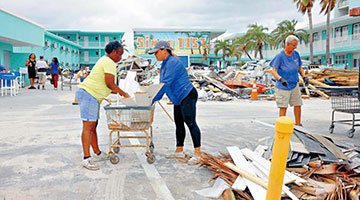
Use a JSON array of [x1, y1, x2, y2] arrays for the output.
[[133, 28, 226, 66]]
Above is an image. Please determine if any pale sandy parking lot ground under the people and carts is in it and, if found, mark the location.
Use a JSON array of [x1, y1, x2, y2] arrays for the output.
[[0, 83, 360, 200]]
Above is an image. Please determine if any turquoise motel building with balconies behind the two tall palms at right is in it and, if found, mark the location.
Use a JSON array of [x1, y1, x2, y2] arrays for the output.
[[264, 0, 360, 69]]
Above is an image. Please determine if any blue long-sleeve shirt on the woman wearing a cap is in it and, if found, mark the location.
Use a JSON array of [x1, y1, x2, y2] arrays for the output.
[[153, 55, 194, 105]]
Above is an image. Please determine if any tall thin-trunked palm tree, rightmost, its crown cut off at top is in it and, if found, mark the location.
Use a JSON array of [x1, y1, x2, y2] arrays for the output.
[[320, 0, 336, 64]]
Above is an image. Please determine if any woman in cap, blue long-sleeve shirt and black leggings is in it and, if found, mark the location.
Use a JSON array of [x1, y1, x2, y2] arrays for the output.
[[149, 41, 201, 161]]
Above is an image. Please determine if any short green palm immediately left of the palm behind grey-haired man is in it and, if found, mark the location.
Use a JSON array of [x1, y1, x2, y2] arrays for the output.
[[244, 23, 270, 59]]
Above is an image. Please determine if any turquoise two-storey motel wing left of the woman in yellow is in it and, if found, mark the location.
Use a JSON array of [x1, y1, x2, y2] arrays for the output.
[[0, 8, 124, 74]]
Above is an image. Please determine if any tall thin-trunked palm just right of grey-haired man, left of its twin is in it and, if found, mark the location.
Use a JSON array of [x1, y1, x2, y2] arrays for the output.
[[293, 0, 315, 62]]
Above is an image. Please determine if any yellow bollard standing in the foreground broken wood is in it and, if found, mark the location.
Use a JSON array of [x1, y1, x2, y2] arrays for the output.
[[266, 117, 294, 200]]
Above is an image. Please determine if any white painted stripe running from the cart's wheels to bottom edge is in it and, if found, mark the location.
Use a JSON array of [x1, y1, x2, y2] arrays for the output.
[[124, 133, 175, 200]]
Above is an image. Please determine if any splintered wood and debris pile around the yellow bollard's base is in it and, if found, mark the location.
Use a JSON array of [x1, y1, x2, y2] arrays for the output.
[[199, 127, 360, 200]]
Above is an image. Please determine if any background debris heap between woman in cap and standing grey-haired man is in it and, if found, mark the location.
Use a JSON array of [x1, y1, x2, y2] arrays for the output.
[[189, 65, 275, 101]]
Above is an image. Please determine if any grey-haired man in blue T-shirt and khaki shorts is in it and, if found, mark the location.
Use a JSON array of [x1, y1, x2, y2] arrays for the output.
[[270, 35, 309, 126]]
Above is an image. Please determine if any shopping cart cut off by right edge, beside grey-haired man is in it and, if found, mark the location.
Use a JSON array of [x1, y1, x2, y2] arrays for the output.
[[329, 89, 360, 138]]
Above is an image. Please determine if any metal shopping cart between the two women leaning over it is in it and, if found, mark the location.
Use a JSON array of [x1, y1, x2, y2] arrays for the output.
[[104, 105, 155, 164]]
